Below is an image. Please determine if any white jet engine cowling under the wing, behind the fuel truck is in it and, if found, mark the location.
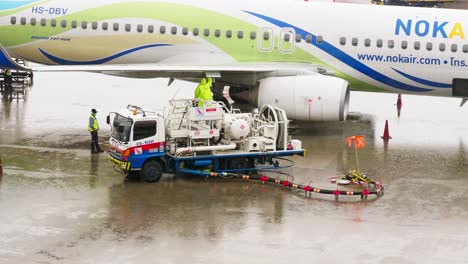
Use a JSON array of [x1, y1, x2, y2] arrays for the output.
[[225, 74, 350, 121]]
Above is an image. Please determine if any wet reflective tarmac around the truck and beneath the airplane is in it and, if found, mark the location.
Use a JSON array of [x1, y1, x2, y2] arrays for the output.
[[0, 73, 468, 263]]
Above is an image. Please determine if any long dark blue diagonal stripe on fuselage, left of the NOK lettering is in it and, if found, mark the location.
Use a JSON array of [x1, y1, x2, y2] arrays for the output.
[[244, 11, 433, 92]]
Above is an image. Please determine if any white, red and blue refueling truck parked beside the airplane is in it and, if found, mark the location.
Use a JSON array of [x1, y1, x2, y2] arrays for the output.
[[107, 99, 306, 182]]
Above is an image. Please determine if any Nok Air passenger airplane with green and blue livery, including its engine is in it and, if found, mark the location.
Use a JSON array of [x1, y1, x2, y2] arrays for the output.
[[0, 0, 468, 121]]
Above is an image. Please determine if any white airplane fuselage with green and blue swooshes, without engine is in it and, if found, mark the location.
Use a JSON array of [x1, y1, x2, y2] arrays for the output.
[[0, 0, 468, 96]]
